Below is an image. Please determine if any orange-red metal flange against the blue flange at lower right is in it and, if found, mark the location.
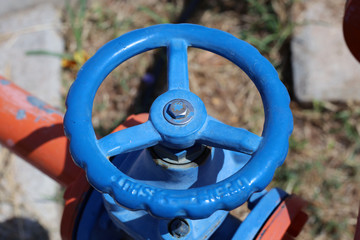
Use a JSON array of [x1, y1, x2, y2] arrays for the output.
[[256, 195, 308, 240]]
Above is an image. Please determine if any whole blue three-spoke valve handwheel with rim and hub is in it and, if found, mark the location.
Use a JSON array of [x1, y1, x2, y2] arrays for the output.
[[64, 24, 293, 219]]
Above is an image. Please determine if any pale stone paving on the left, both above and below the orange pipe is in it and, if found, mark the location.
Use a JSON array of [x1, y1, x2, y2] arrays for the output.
[[0, 0, 64, 239]]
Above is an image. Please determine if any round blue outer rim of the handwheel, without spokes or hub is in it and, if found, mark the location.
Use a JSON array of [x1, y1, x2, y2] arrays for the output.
[[64, 24, 292, 219]]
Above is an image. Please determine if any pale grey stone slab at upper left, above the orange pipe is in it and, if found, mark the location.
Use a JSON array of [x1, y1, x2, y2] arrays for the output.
[[0, 4, 64, 106]]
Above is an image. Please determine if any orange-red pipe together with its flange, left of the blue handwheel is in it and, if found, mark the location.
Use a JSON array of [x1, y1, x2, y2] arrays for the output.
[[0, 76, 148, 239]]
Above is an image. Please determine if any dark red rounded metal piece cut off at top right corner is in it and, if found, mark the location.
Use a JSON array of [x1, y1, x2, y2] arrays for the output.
[[343, 0, 360, 62]]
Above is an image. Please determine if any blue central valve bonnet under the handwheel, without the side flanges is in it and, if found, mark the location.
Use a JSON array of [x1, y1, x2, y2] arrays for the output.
[[100, 148, 250, 239]]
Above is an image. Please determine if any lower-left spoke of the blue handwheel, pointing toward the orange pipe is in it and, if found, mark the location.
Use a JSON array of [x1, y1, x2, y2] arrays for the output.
[[98, 121, 161, 157]]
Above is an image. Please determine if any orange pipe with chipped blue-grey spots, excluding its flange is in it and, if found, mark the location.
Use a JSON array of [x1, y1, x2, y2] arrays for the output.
[[0, 76, 80, 186]]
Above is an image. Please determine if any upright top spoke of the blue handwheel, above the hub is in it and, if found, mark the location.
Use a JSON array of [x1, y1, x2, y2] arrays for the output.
[[167, 39, 189, 90]]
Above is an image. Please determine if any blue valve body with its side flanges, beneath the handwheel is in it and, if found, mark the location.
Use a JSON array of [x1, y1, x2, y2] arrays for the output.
[[75, 149, 287, 240]]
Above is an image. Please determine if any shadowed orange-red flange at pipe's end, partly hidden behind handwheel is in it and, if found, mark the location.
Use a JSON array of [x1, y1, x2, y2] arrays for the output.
[[61, 113, 149, 240]]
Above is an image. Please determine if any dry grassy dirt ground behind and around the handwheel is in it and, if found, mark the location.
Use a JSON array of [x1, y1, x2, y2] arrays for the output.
[[58, 0, 360, 239]]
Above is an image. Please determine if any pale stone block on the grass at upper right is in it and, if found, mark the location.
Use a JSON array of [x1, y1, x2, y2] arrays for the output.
[[291, 0, 360, 102]]
